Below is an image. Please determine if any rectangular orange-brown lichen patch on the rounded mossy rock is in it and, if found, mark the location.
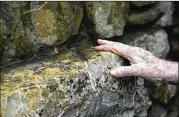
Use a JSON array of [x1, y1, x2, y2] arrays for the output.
[[35, 9, 54, 39]]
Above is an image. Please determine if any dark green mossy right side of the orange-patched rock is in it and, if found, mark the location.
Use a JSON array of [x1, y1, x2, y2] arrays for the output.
[[55, 2, 83, 44]]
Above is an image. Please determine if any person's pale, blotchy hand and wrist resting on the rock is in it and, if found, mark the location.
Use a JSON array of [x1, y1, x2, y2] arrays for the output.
[[95, 39, 179, 84]]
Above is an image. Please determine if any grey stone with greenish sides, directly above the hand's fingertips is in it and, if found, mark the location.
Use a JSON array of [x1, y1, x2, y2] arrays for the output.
[[85, 1, 129, 38]]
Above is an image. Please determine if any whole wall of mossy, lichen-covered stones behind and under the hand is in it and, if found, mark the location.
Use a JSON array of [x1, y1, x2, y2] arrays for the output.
[[0, 1, 179, 117]]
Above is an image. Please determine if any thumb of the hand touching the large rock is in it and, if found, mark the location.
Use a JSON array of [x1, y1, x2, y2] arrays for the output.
[[110, 65, 140, 77]]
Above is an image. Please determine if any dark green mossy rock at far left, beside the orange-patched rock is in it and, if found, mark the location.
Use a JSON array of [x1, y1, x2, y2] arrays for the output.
[[1, 2, 38, 64]]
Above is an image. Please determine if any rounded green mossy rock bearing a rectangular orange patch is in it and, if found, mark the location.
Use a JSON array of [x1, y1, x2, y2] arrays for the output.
[[32, 2, 83, 45]]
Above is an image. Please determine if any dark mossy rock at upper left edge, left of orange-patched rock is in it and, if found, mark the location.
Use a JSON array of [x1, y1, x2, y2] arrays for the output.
[[0, 2, 38, 61]]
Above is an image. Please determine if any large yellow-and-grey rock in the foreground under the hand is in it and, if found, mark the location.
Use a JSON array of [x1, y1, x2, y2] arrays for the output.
[[1, 39, 151, 117]]
